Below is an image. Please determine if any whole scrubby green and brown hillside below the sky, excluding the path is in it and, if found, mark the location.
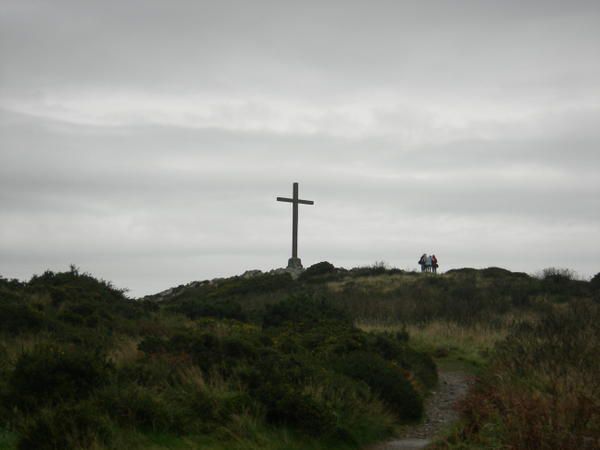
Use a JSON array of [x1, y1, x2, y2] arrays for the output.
[[0, 263, 600, 450]]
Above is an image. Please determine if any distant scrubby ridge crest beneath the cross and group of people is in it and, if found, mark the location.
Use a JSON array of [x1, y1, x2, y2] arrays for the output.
[[157, 262, 599, 323]]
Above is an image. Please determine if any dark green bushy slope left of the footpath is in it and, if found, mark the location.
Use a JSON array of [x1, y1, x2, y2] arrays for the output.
[[0, 268, 437, 449]]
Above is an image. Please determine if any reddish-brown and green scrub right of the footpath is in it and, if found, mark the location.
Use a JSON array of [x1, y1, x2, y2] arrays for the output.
[[438, 302, 600, 449]]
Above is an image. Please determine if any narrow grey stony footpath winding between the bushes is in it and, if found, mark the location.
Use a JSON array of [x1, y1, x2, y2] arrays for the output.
[[369, 371, 472, 450]]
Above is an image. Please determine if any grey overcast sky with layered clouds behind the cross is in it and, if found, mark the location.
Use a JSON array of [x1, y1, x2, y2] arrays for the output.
[[0, 0, 600, 296]]
